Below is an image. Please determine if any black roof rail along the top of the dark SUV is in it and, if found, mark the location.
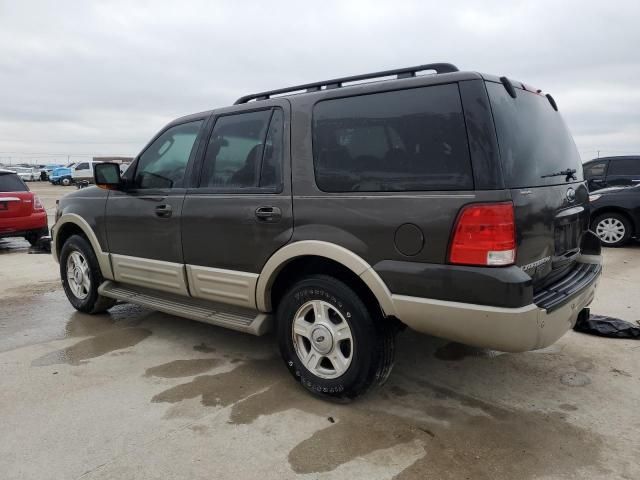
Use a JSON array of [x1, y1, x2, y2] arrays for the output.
[[234, 63, 458, 105]]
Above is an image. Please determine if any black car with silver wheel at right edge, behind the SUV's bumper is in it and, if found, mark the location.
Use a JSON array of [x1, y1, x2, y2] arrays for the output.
[[589, 184, 640, 247]]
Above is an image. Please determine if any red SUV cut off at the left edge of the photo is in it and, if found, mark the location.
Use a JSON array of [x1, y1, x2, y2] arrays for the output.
[[0, 169, 49, 245]]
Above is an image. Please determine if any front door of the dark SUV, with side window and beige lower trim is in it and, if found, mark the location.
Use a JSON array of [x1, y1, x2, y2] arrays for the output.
[[106, 120, 203, 295]]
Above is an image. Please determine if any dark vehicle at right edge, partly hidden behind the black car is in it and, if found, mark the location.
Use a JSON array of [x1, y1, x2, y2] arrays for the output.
[[583, 155, 640, 191]]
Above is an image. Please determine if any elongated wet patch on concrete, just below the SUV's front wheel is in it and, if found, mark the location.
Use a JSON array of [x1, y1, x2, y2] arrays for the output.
[[31, 327, 151, 367]]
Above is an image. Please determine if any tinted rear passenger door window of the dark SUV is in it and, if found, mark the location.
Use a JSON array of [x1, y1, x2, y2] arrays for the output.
[[200, 109, 282, 189]]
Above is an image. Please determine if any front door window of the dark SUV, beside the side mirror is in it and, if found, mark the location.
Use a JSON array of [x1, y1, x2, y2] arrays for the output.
[[135, 120, 202, 188]]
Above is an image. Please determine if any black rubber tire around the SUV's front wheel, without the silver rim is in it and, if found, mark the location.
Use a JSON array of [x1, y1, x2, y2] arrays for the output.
[[60, 235, 116, 314]]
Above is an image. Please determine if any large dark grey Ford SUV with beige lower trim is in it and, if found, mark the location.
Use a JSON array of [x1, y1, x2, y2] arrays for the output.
[[52, 64, 601, 399]]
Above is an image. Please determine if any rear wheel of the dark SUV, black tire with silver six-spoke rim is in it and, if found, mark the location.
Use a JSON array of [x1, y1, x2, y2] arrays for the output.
[[277, 275, 396, 400]]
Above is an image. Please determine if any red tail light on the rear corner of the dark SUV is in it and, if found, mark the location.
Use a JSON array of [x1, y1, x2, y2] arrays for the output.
[[449, 202, 516, 266]]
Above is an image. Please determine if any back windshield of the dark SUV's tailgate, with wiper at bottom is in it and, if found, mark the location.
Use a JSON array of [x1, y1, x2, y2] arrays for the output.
[[486, 82, 584, 188]]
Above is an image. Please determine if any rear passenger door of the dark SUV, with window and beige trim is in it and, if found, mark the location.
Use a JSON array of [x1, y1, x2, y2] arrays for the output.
[[182, 103, 293, 308]]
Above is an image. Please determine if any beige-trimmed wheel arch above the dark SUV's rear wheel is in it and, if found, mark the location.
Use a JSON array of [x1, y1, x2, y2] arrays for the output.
[[256, 240, 395, 316]]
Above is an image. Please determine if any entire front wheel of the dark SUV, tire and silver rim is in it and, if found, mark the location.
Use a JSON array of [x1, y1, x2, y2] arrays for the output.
[[60, 235, 116, 313]]
